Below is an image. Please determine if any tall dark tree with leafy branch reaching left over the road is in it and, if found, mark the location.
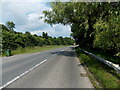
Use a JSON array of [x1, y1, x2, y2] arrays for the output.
[[43, 2, 99, 46]]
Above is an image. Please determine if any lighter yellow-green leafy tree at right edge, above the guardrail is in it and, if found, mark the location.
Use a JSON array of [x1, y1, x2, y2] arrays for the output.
[[94, 3, 120, 53]]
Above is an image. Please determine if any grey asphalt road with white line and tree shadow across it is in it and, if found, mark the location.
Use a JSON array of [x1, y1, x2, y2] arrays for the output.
[[2, 47, 93, 88]]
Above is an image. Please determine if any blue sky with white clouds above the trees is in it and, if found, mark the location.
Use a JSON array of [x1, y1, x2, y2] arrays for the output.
[[0, 0, 71, 37]]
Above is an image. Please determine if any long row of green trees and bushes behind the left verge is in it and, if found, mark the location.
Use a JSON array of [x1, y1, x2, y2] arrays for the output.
[[0, 21, 74, 52]]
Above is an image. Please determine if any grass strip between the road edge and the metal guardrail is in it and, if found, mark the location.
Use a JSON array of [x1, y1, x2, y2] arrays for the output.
[[76, 48, 120, 88]]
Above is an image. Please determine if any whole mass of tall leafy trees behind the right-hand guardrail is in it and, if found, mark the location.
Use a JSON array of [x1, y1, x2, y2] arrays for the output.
[[43, 2, 120, 56]]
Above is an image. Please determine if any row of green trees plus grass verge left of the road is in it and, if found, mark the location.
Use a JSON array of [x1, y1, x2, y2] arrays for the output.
[[0, 21, 74, 56]]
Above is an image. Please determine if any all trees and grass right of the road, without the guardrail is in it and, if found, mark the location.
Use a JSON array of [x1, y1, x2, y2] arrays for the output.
[[43, 2, 120, 88]]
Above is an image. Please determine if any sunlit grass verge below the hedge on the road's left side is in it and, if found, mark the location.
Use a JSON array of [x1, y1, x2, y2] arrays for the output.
[[2, 45, 67, 56]]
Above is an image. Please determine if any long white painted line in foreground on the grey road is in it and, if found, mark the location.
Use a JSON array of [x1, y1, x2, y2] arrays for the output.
[[0, 59, 47, 90]]
